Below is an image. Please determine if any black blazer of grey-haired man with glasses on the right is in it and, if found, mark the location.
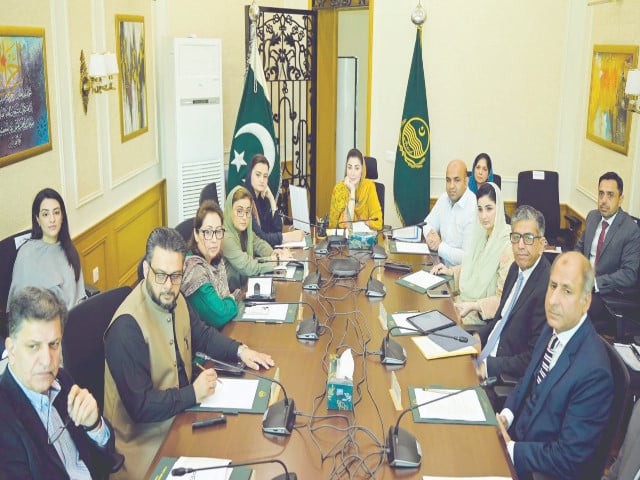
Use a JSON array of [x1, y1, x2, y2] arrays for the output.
[[478, 255, 551, 378]]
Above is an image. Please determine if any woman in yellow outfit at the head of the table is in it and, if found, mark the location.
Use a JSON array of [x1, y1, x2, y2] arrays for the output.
[[329, 148, 382, 230]]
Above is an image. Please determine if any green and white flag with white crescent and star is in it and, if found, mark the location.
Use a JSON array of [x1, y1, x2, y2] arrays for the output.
[[227, 25, 281, 199]]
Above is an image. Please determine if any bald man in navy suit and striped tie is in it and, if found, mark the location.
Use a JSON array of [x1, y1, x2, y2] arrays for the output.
[[497, 252, 613, 479]]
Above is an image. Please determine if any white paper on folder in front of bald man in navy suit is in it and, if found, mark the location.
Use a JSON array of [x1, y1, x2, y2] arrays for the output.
[[414, 388, 487, 422]]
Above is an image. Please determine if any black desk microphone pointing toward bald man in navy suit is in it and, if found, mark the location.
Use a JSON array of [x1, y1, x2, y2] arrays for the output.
[[387, 377, 496, 468]]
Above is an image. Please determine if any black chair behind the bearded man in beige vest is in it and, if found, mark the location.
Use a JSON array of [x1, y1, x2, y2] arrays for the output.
[[62, 286, 131, 478]]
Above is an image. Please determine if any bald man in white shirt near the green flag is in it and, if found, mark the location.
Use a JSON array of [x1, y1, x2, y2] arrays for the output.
[[422, 160, 477, 267]]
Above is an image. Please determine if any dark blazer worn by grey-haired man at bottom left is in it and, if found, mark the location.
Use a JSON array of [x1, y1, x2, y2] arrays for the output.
[[0, 368, 115, 480]]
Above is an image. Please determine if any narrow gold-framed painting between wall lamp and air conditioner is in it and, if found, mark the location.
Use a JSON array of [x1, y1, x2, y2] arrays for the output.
[[116, 15, 148, 142]]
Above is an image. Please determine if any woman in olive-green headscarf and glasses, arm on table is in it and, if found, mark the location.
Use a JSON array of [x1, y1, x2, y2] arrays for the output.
[[222, 186, 291, 291]]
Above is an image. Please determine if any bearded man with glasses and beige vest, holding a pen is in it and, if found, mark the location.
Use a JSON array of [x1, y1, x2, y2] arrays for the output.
[[104, 228, 274, 479]]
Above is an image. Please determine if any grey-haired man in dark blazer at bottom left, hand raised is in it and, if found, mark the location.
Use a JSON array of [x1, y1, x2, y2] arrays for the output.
[[0, 287, 114, 479]]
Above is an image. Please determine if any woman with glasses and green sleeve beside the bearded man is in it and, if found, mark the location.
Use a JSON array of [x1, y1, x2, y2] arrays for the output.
[[180, 200, 242, 328]]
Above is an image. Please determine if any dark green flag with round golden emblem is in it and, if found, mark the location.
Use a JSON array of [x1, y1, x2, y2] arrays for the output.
[[393, 28, 431, 225]]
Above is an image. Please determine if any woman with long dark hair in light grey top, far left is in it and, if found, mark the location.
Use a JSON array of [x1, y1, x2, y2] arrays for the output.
[[7, 188, 86, 309]]
